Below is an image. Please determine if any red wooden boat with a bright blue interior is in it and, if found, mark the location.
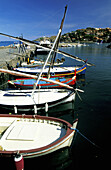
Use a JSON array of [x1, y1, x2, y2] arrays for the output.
[[8, 76, 76, 89]]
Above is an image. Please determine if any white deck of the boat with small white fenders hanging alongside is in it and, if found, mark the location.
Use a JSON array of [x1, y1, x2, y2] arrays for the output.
[[0, 89, 69, 106]]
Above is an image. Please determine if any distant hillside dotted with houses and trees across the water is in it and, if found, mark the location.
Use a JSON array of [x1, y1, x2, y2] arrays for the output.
[[35, 27, 111, 43]]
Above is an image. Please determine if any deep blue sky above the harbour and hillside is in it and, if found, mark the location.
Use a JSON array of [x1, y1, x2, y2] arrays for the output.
[[0, 0, 111, 41]]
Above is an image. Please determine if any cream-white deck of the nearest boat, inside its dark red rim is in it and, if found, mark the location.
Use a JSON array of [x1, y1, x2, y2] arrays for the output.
[[0, 118, 66, 151]]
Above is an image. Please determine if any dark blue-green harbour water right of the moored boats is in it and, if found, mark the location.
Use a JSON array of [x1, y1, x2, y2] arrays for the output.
[[0, 44, 111, 170]]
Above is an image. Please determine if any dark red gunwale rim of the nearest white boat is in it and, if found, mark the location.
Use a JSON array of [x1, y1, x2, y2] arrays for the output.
[[0, 114, 78, 157]]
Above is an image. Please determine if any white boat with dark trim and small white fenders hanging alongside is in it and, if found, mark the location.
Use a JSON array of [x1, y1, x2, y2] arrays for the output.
[[0, 89, 75, 113]]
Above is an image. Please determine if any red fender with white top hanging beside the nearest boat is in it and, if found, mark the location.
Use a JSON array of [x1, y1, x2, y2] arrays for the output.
[[14, 154, 24, 170]]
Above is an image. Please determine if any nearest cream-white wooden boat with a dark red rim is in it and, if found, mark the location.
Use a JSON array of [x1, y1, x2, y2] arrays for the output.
[[0, 114, 78, 169]]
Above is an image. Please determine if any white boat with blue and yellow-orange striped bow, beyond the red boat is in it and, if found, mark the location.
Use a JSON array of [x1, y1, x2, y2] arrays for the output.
[[14, 64, 87, 77]]
